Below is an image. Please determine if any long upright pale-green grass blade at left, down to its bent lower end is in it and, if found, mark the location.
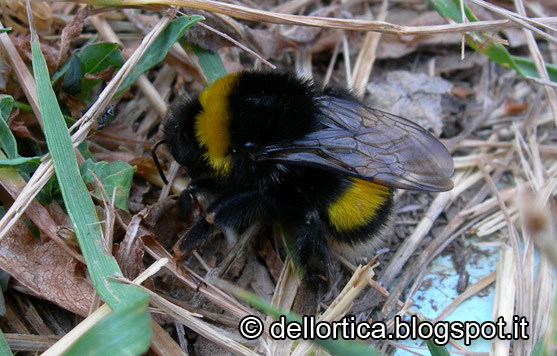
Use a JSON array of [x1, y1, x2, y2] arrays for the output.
[[31, 32, 144, 309]]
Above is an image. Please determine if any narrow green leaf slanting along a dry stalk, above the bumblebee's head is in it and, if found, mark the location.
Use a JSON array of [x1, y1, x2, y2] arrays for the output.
[[114, 15, 203, 97]]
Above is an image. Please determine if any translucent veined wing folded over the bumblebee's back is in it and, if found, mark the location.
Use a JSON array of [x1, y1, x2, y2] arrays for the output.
[[262, 95, 454, 191]]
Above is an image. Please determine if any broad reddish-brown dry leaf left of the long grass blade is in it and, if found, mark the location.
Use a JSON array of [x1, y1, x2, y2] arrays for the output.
[[0, 220, 94, 316]]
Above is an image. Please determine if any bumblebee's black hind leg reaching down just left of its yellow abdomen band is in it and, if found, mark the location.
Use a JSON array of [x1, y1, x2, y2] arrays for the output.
[[281, 211, 330, 315]]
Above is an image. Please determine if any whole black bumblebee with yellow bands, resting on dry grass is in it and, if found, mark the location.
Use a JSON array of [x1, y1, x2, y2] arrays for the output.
[[164, 71, 454, 300]]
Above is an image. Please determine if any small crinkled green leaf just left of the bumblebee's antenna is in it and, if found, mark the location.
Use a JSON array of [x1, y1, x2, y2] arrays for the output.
[[81, 159, 136, 212]]
